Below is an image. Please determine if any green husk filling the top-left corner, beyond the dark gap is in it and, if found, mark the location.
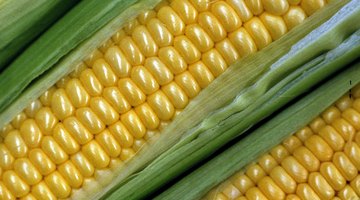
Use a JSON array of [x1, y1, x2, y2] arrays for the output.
[[0, 0, 79, 72]]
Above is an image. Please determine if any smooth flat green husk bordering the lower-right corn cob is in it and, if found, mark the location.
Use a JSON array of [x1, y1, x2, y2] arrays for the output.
[[159, 61, 360, 199]]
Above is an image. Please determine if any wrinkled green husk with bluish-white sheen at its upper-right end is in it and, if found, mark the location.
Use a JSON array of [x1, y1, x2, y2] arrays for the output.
[[104, 1, 360, 199]]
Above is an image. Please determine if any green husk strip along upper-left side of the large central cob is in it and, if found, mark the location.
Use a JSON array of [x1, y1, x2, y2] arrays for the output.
[[0, 0, 137, 112]]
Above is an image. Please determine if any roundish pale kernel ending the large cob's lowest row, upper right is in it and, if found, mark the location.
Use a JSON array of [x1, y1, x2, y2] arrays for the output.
[[283, 6, 307, 30]]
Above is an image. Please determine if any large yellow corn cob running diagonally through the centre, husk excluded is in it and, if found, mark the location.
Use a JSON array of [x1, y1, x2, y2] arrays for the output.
[[0, 0, 326, 199]]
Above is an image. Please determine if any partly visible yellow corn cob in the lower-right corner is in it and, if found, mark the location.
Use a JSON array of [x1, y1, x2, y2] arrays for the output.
[[207, 85, 360, 200]]
